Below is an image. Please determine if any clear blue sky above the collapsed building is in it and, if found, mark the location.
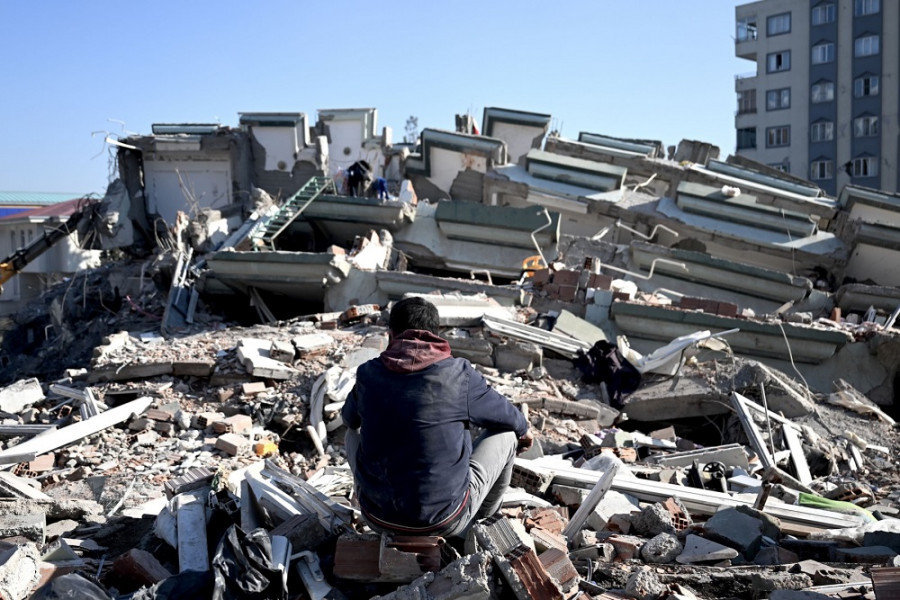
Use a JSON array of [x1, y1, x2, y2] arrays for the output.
[[0, 0, 753, 193]]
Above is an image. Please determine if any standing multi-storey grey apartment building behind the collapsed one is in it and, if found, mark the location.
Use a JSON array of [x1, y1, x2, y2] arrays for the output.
[[735, 0, 900, 195]]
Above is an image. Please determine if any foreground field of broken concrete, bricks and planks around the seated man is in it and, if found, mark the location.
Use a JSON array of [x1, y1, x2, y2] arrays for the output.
[[0, 254, 900, 600]]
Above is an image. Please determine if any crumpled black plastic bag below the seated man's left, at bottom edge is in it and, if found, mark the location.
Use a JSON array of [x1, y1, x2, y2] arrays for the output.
[[213, 525, 286, 600]]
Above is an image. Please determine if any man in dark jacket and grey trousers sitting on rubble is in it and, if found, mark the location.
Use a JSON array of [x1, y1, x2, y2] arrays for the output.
[[341, 297, 533, 537]]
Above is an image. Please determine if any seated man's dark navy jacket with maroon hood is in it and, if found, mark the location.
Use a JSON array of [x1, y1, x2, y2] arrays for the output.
[[341, 329, 528, 533]]
